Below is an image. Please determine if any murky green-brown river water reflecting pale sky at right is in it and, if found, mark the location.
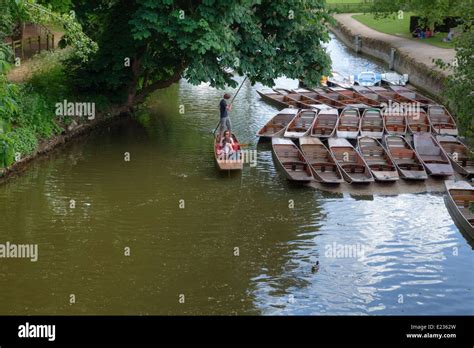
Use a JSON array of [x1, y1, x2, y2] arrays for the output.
[[0, 34, 474, 315]]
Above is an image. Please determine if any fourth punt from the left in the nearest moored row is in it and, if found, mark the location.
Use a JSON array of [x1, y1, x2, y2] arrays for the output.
[[357, 136, 400, 182]]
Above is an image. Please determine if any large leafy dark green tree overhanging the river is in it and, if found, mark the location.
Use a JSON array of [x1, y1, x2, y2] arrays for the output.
[[70, 0, 331, 106]]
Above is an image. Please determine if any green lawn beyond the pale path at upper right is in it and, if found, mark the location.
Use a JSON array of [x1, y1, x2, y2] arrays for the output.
[[352, 12, 454, 48]]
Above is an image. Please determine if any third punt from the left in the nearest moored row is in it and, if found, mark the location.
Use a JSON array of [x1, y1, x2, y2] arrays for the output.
[[328, 138, 374, 183]]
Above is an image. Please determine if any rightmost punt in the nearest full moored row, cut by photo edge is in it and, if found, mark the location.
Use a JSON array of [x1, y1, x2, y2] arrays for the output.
[[436, 135, 474, 176]]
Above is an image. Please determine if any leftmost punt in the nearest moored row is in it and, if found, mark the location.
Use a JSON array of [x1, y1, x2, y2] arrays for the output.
[[272, 137, 314, 182]]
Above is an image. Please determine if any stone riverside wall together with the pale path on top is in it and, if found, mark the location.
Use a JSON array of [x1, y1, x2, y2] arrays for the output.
[[330, 13, 455, 101]]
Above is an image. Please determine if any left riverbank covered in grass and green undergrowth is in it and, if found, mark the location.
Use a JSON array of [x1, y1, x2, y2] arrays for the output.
[[0, 50, 108, 172]]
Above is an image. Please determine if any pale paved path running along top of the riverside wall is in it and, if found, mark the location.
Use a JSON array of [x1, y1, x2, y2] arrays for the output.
[[334, 13, 456, 73]]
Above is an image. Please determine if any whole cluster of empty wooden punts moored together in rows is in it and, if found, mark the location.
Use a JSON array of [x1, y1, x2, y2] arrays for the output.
[[257, 86, 474, 183]]
